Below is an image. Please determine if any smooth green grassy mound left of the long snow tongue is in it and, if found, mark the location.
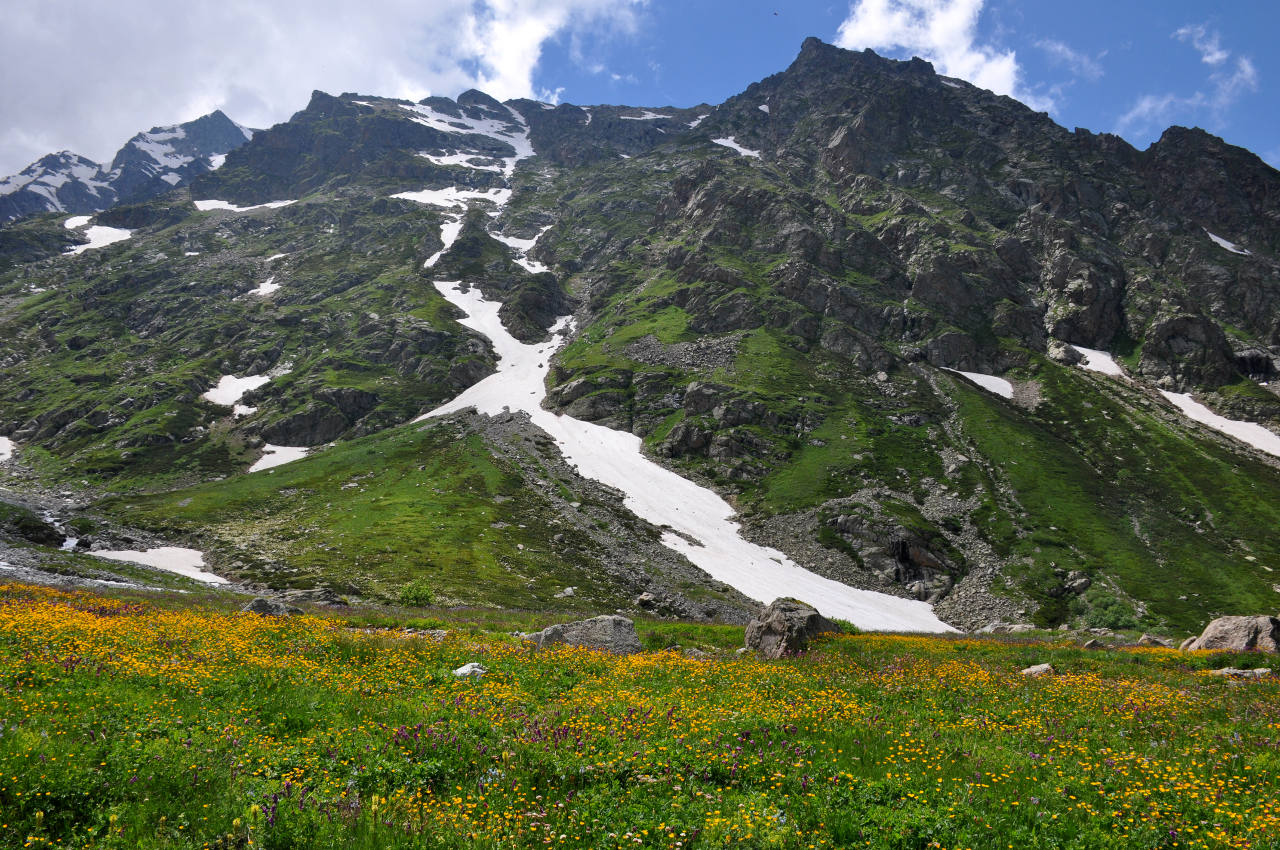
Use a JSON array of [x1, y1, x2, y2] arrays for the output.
[[97, 414, 645, 608]]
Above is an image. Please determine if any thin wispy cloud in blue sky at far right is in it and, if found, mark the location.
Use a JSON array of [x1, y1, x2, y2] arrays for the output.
[[1116, 24, 1258, 133]]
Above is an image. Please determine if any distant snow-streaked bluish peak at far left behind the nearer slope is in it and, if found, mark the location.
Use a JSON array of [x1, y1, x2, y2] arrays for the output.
[[0, 110, 253, 221]]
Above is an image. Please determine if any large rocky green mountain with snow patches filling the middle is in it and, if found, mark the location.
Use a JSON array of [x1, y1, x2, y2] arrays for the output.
[[0, 40, 1280, 637]]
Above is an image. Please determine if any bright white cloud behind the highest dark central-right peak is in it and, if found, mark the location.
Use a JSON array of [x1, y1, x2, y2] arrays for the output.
[[836, 0, 1053, 109]]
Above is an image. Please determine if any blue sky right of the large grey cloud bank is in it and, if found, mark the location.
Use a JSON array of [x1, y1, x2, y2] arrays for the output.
[[535, 0, 1280, 166]]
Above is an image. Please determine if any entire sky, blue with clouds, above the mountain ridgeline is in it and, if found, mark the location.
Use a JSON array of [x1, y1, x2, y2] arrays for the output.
[[0, 0, 1280, 175]]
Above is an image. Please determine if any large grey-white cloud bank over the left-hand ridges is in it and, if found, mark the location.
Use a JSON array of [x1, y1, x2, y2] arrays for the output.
[[0, 0, 646, 174]]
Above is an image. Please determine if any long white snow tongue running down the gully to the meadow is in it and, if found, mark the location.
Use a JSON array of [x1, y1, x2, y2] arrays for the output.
[[420, 282, 955, 632]]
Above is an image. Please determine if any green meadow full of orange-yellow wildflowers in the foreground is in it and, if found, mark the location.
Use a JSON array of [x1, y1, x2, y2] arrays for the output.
[[0, 585, 1280, 850]]
